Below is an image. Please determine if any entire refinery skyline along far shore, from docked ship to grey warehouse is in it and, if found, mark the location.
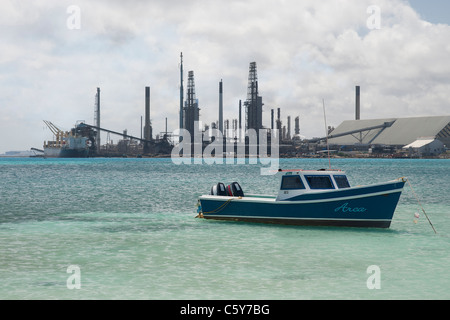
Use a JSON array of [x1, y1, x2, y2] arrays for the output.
[[32, 53, 450, 158]]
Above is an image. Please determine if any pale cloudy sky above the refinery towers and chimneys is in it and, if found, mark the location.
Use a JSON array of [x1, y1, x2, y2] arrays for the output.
[[0, 0, 450, 154]]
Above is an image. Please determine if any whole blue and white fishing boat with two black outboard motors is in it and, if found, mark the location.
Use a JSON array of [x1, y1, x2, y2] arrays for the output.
[[197, 169, 407, 228]]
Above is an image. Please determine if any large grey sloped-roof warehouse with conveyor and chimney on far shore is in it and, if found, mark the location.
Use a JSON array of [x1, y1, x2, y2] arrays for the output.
[[308, 86, 450, 156]]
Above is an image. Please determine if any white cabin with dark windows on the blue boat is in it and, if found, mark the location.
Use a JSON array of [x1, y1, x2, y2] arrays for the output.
[[277, 169, 350, 201]]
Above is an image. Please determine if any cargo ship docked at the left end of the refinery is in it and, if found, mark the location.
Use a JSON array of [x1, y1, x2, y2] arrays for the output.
[[44, 120, 96, 158]]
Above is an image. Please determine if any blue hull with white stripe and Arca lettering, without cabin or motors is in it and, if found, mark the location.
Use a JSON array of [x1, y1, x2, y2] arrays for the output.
[[199, 180, 405, 228]]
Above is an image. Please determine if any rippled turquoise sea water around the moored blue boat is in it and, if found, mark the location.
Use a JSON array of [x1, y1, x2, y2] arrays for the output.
[[0, 158, 450, 299]]
